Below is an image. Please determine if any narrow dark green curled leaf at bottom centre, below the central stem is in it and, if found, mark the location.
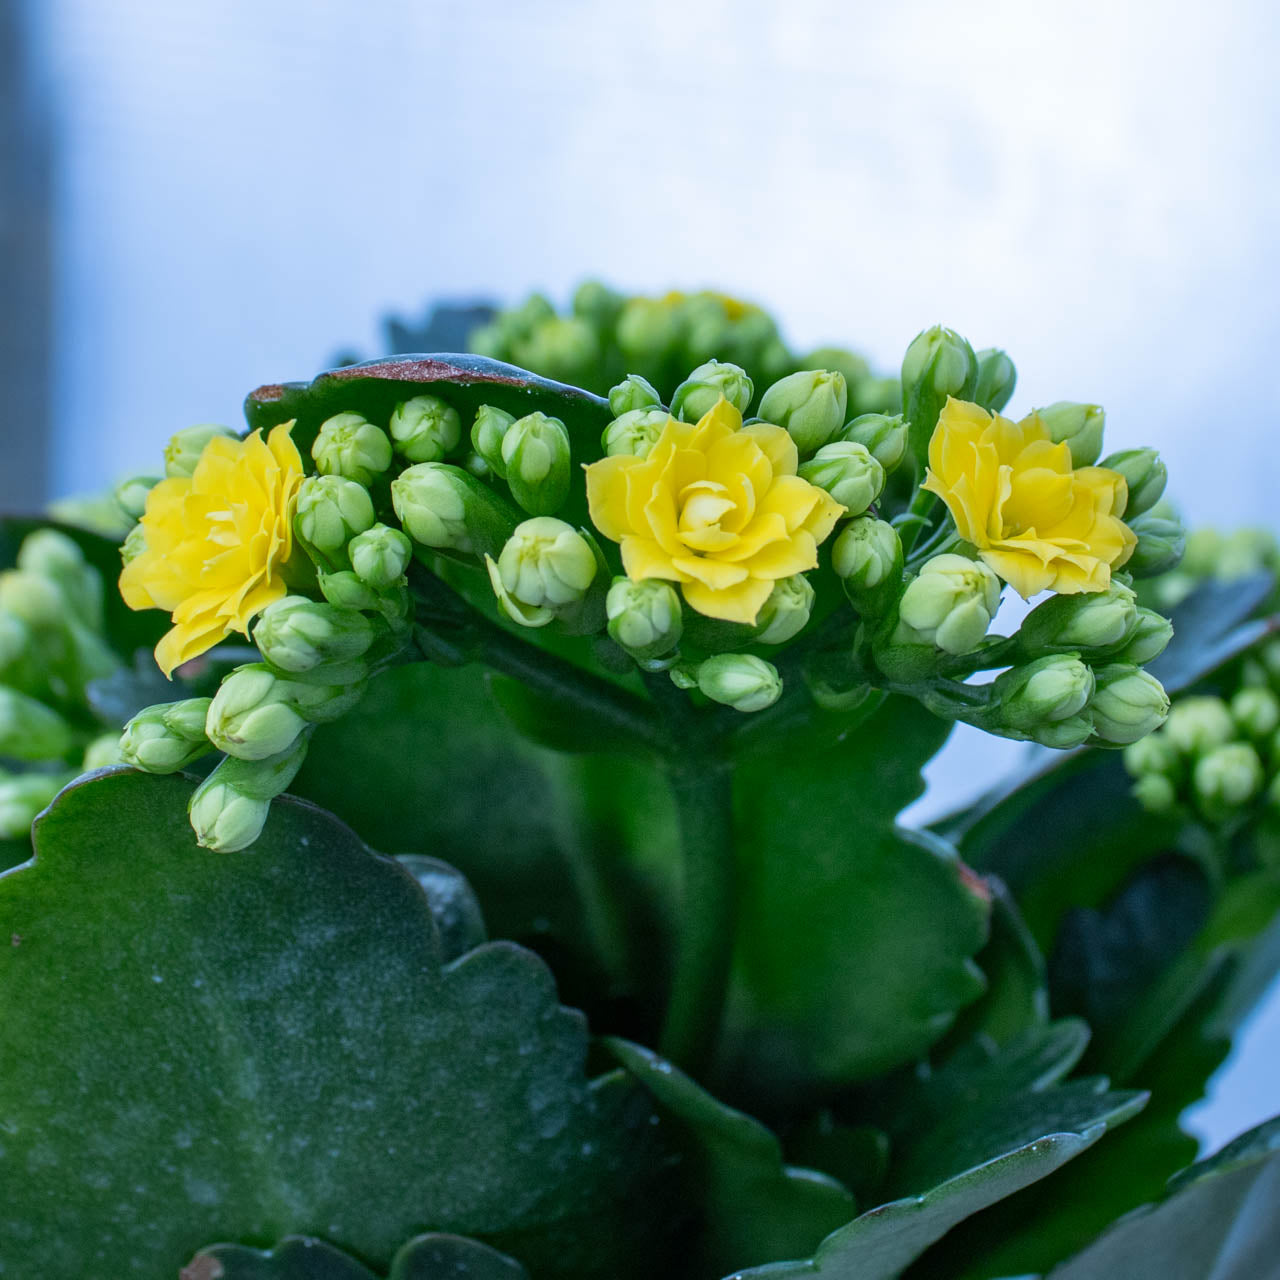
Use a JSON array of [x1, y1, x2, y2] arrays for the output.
[[607, 1039, 854, 1276]]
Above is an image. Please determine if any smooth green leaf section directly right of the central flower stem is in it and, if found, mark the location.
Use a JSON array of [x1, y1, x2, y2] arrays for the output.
[[731, 698, 989, 1093]]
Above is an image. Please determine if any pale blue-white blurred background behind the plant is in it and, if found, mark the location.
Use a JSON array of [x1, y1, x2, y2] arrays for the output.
[[0, 0, 1280, 1147]]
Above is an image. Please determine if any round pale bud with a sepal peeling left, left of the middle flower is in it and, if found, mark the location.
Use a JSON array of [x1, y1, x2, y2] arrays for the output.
[[485, 516, 598, 627]]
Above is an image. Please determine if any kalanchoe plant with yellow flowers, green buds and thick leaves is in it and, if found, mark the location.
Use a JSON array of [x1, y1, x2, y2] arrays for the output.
[[0, 287, 1280, 1280]]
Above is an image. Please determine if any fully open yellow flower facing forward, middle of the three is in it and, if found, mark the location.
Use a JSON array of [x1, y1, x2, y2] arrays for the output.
[[586, 398, 845, 622]]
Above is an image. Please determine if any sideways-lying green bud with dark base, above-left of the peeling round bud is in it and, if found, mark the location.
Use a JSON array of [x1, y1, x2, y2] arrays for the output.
[[392, 462, 517, 556]]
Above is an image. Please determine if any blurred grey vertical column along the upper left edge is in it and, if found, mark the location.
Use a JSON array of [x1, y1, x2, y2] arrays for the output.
[[0, 0, 51, 512]]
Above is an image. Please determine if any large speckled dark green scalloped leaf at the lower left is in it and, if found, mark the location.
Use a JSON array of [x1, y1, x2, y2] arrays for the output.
[[0, 771, 663, 1280]]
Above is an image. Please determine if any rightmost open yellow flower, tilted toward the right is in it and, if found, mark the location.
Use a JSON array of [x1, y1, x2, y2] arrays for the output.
[[924, 398, 1137, 599]]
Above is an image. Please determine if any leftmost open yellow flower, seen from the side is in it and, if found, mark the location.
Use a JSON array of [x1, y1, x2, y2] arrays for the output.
[[120, 422, 302, 676]]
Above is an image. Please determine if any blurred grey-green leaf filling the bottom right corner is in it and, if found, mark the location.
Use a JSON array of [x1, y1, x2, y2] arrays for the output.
[[1050, 1119, 1280, 1280]]
